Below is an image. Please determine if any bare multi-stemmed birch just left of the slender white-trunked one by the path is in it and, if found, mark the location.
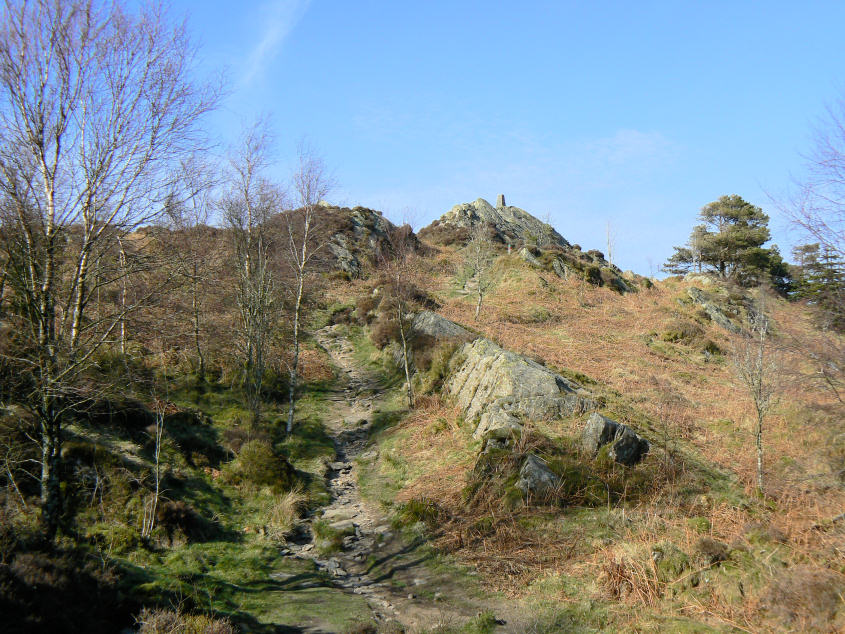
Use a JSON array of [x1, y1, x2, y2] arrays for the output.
[[221, 123, 282, 427]]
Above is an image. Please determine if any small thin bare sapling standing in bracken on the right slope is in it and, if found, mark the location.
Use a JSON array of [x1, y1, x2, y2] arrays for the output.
[[733, 289, 780, 495]]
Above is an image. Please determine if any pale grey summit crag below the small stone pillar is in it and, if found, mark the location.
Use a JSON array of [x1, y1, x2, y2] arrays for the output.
[[432, 196, 569, 247]]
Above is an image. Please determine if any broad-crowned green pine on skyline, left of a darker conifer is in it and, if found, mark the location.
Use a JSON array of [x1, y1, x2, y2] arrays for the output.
[[664, 194, 790, 292]]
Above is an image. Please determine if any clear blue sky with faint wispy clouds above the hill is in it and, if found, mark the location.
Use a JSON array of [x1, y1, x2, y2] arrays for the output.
[[173, 0, 845, 274]]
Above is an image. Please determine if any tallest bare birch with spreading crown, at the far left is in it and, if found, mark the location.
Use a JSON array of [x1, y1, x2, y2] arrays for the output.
[[0, 0, 217, 536]]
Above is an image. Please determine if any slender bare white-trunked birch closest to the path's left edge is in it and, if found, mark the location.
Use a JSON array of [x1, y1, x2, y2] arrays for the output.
[[284, 147, 333, 435]]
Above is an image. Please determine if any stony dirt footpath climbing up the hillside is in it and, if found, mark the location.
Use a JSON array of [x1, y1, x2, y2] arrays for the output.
[[289, 326, 524, 632]]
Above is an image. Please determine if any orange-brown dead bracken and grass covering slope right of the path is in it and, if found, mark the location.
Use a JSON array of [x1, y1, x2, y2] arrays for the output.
[[335, 244, 845, 631]]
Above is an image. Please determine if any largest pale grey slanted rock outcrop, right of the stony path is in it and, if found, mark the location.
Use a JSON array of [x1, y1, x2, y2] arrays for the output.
[[446, 338, 596, 440]]
